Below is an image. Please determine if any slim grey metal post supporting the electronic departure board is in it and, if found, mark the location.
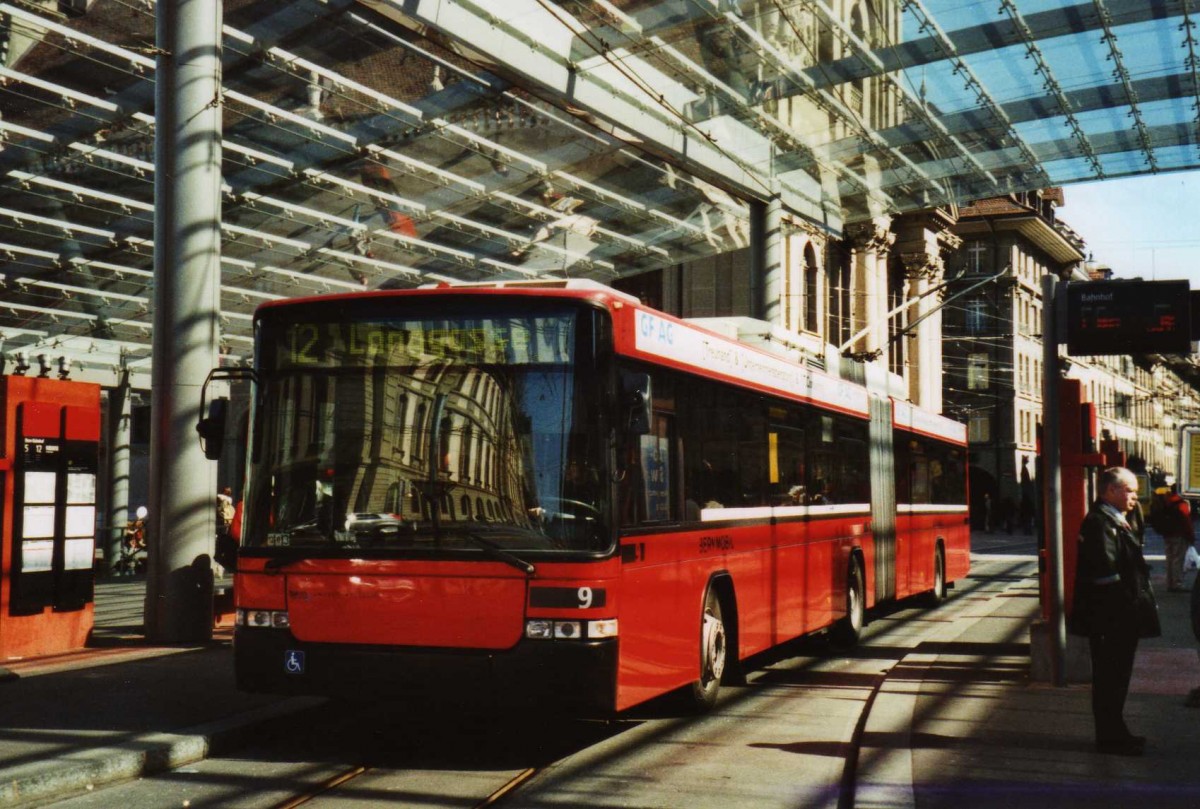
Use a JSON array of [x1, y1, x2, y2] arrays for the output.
[[1042, 275, 1067, 687]]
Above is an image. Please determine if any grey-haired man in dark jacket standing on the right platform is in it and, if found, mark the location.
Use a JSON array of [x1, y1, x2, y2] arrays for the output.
[[1072, 467, 1162, 756]]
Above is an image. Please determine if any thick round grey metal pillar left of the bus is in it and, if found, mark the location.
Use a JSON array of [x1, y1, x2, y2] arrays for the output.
[[145, 0, 222, 643]]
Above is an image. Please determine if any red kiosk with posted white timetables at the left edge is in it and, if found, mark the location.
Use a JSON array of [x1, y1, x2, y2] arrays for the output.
[[0, 376, 100, 663]]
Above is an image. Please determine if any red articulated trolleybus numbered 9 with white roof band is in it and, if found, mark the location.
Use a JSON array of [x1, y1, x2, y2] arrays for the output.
[[202, 281, 970, 711]]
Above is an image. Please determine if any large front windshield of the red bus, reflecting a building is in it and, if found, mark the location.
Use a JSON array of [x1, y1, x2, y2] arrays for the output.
[[242, 298, 612, 558]]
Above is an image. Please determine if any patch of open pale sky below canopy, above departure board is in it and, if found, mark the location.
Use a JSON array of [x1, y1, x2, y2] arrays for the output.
[[1057, 172, 1200, 289]]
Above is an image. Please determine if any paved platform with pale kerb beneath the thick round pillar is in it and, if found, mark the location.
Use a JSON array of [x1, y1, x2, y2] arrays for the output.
[[0, 577, 319, 807]]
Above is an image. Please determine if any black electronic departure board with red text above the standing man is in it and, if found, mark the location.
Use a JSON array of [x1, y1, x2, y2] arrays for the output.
[[1067, 280, 1192, 356]]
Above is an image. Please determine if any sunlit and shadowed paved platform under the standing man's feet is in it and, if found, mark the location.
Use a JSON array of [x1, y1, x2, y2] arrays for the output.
[[854, 541, 1200, 809]]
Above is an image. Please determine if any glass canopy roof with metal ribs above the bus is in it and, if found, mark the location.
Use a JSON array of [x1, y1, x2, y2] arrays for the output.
[[0, 0, 1200, 372]]
